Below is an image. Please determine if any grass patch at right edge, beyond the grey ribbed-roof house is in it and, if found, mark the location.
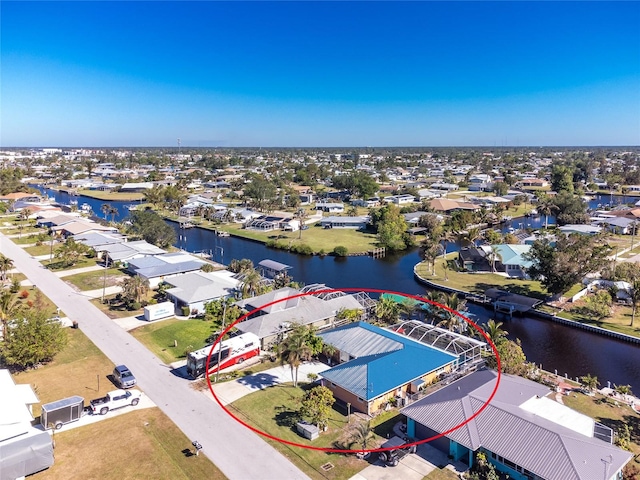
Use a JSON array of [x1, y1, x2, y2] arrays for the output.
[[562, 393, 640, 454]]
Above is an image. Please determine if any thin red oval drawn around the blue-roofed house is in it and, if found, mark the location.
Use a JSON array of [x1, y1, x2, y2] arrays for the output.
[[205, 288, 502, 453]]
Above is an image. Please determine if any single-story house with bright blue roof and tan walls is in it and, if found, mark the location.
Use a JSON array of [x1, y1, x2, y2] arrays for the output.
[[318, 322, 458, 415]]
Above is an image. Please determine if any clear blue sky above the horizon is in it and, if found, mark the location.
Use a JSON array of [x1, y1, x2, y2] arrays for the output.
[[0, 1, 640, 147]]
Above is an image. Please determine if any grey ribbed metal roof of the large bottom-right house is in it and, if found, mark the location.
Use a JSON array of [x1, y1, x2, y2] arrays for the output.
[[401, 370, 631, 480]]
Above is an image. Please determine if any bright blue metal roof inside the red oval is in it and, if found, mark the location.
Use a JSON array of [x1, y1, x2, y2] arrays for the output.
[[320, 322, 456, 401]]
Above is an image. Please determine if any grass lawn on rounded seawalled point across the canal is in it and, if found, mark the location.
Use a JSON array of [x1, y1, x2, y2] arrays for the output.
[[416, 253, 547, 300]]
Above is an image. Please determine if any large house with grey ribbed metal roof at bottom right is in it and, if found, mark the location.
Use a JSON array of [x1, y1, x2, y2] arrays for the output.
[[401, 370, 632, 480]]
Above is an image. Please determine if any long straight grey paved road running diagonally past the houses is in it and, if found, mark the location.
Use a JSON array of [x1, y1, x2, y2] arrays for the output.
[[0, 233, 308, 480]]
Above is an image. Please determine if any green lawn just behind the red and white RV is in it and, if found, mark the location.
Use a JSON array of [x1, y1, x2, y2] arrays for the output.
[[131, 319, 213, 363]]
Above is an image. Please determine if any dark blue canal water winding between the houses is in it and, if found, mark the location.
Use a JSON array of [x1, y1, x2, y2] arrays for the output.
[[35, 186, 640, 394]]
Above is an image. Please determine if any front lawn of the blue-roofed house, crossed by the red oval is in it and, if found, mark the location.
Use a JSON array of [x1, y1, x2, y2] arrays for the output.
[[229, 384, 398, 480]]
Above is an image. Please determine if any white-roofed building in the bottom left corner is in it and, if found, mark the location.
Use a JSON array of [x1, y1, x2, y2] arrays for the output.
[[0, 369, 54, 479]]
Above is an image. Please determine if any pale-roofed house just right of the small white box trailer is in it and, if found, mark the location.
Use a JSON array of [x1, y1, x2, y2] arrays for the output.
[[165, 270, 240, 315]]
